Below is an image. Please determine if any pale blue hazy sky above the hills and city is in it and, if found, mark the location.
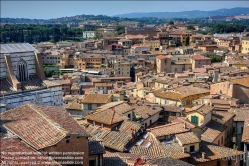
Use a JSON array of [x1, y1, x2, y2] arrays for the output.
[[1, 0, 249, 19]]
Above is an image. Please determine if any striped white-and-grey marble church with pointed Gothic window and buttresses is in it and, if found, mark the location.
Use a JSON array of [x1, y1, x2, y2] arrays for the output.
[[0, 43, 62, 112]]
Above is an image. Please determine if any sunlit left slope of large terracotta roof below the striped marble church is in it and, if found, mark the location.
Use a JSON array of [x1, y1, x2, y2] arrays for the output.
[[1, 104, 67, 149]]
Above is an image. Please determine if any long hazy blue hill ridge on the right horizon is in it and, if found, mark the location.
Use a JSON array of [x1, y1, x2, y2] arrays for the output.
[[115, 7, 249, 18]]
